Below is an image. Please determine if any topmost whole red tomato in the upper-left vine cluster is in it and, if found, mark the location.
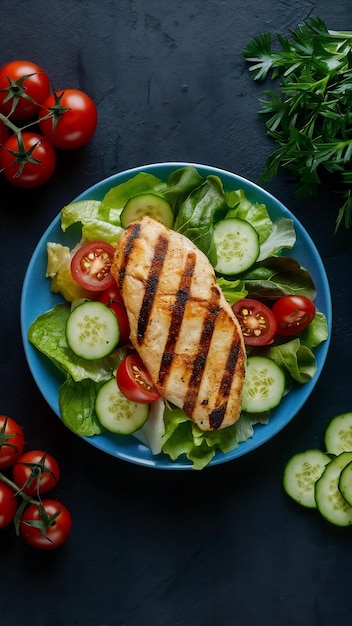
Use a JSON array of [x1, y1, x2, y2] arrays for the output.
[[0, 60, 50, 120]]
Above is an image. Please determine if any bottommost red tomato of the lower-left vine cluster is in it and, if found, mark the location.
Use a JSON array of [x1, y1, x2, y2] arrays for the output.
[[20, 500, 72, 550]]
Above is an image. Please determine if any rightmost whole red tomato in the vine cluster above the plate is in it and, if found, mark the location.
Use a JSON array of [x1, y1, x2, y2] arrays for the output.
[[39, 89, 98, 150]]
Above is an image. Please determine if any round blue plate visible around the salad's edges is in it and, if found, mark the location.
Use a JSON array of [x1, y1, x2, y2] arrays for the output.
[[21, 162, 332, 470]]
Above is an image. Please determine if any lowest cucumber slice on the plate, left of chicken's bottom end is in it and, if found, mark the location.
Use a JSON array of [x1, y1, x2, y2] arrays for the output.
[[95, 377, 150, 435]]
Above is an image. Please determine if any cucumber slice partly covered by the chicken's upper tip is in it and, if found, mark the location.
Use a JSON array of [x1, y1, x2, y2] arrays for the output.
[[121, 193, 174, 228]]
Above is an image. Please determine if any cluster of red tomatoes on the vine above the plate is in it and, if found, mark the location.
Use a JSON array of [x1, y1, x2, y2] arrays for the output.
[[0, 61, 98, 189]]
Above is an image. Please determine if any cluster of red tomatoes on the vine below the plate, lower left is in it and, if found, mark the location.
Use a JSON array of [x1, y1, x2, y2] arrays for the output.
[[0, 415, 72, 550]]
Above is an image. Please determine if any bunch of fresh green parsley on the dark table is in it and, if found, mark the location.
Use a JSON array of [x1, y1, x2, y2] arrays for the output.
[[243, 17, 352, 229]]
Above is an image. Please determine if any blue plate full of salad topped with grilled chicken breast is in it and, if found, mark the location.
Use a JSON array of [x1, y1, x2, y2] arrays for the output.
[[21, 163, 331, 469]]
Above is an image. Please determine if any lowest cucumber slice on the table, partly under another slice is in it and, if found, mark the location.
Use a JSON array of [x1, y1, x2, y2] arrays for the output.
[[315, 452, 352, 526]]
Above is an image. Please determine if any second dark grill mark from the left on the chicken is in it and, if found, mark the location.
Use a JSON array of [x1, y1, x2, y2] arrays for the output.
[[137, 235, 169, 345]]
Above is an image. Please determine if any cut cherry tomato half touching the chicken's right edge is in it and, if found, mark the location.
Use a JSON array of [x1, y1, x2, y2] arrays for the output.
[[232, 298, 277, 346]]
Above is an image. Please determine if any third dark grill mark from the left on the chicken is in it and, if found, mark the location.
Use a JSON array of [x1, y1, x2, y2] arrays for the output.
[[158, 252, 196, 385]]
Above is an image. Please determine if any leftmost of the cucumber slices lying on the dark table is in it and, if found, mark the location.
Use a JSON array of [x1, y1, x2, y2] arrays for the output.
[[283, 449, 331, 509]]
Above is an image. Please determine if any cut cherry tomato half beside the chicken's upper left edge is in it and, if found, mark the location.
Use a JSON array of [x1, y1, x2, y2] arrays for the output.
[[71, 241, 115, 292]]
